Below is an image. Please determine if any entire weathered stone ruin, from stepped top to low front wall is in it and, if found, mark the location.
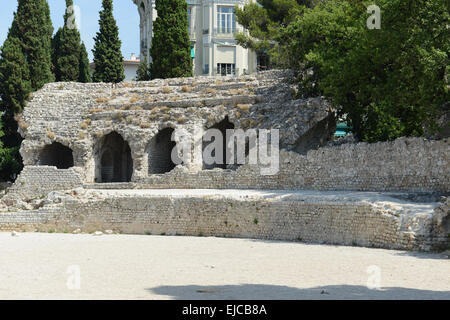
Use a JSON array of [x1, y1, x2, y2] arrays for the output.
[[0, 71, 450, 250]]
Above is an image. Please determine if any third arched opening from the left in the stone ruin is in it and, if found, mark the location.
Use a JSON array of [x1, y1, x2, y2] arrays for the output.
[[147, 128, 176, 174]]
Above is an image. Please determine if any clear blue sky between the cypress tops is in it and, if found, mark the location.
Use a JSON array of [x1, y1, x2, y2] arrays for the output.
[[0, 0, 140, 61]]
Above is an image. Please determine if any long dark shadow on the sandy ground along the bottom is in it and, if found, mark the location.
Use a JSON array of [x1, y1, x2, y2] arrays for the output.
[[147, 284, 450, 300]]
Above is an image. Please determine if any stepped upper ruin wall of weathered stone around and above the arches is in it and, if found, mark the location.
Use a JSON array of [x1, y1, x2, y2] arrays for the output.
[[19, 72, 335, 183]]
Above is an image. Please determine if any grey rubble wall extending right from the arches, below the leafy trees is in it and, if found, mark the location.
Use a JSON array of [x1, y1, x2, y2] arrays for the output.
[[125, 138, 450, 193]]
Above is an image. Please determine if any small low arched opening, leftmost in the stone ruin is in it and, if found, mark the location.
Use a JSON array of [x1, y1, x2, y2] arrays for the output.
[[38, 142, 74, 169]]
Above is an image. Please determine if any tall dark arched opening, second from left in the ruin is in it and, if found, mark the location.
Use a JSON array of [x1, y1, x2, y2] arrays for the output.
[[96, 132, 133, 183]]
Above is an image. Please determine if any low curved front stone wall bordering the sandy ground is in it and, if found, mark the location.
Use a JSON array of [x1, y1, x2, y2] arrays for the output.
[[0, 190, 449, 250]]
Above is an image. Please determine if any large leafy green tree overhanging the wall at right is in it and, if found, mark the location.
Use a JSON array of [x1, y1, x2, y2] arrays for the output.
[[280, 0, 450, 142]]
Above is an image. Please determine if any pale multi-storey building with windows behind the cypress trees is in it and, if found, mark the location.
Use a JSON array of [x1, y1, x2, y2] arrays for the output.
[[133, 0, 257, 76]]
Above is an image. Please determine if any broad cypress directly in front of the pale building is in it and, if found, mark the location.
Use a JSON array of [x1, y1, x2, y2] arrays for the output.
[[150, 0, 192, 79]]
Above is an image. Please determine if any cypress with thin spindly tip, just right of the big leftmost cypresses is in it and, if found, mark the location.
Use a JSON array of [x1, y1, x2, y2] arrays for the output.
[[52, 0, 81, 81]]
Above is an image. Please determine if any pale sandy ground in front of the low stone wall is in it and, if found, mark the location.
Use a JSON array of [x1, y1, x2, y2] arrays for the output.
[[0, 233, 450, 300]]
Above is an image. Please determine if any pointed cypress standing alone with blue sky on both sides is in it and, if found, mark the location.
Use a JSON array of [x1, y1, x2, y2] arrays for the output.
[[93, 0, 125, 83]]
